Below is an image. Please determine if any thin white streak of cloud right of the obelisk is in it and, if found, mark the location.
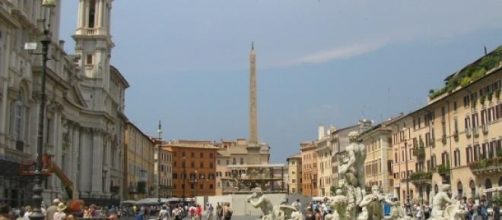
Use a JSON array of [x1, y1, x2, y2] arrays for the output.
[[293, 40, 387, 64]]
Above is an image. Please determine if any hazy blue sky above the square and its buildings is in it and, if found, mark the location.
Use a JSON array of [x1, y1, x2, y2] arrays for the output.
[[60, 0, 502, 162]]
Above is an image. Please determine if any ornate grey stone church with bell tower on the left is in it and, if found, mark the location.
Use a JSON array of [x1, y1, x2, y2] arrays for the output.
[[0, 0, 129, 206]]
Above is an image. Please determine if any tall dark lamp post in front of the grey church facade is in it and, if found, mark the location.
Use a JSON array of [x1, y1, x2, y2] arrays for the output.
[[30, 0, 56, 220]]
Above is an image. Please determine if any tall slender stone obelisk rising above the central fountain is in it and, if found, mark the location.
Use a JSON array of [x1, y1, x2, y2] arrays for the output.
[[249, 42, 258, 145]]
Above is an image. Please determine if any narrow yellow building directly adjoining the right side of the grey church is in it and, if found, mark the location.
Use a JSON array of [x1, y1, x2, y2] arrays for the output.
[[123, 122, 156, 200]]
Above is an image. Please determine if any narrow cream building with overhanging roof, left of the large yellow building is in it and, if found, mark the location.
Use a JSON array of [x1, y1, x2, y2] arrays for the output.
[[359, 117, 400, 194]]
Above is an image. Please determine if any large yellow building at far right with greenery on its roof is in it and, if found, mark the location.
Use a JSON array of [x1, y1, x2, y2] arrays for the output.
[[392, 48, 502, 204]]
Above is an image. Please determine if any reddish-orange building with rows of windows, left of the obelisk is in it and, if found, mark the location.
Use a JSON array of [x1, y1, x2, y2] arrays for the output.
[[164, 140, 218, 198]]
